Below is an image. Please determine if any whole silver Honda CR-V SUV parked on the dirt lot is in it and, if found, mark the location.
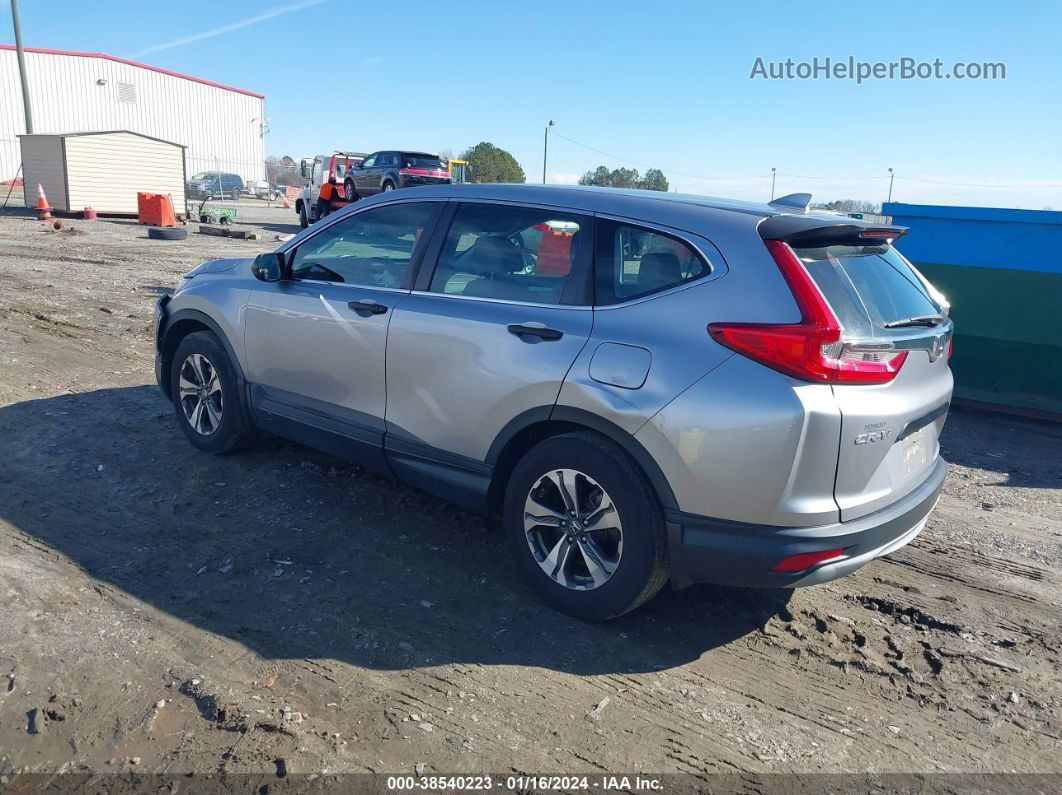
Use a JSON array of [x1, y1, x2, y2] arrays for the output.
[[155, 185, 953, 619]]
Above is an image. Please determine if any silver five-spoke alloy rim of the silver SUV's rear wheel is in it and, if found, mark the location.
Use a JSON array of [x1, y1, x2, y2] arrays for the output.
[[524, 469, 623, 591]]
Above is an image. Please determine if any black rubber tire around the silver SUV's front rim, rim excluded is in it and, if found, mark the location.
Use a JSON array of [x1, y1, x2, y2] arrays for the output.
[[170, 331, 256, 453]]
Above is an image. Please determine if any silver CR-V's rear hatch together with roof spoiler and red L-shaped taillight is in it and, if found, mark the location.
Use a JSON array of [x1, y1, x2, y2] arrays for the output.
[[708, 214, 953, 521]]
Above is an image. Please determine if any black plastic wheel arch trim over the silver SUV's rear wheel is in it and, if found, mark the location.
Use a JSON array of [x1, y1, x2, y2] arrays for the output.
[[485, 405, 679, 515]]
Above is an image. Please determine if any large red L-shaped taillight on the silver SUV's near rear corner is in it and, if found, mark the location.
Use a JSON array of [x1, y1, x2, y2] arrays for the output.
[[708, 240, 907, 384]]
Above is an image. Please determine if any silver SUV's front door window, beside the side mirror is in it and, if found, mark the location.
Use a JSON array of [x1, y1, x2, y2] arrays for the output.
[[291, 202, 436, 288]]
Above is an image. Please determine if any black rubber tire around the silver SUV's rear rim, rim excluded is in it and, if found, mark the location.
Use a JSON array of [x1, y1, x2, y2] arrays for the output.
[[502, 432, 669, 621]]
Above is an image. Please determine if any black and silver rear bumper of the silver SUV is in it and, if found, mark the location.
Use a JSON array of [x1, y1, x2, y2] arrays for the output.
[[667, 459, 947, 588]]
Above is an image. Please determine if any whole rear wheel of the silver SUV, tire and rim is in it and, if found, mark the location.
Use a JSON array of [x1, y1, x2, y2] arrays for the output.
[[503, 433, 668, 621]]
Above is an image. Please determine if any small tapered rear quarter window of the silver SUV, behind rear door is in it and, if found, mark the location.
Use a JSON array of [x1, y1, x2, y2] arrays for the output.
[[594, 221, 712, 306]]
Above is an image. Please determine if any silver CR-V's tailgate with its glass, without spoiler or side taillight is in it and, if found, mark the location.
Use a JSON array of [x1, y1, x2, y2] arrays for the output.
[[791, 231, 953, 521]]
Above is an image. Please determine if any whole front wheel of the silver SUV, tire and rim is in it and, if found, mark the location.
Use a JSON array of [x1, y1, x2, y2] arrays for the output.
[[170, 331, 254, 453]]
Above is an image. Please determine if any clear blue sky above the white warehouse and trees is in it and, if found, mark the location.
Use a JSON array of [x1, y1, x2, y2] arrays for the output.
[[6, 0, 1062, 209]]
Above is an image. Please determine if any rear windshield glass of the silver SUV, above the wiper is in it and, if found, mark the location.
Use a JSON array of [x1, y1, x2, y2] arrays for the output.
[[793, 245, 942, 336]]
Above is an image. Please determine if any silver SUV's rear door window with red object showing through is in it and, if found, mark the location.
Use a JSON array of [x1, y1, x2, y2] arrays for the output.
[[429, 204, 586, 304]]
